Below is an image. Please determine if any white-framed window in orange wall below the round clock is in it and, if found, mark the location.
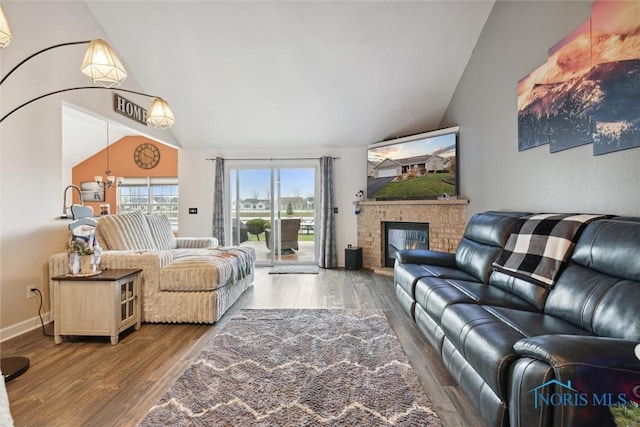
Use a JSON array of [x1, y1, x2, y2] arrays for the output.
[[118, 177, 178, 231]]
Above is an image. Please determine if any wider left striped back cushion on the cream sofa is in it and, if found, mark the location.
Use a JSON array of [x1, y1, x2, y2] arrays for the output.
[[98, 211, 156, 251]]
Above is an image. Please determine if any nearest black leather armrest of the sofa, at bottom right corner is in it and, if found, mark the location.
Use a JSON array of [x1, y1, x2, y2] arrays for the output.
[[509, 335, 640, 427]]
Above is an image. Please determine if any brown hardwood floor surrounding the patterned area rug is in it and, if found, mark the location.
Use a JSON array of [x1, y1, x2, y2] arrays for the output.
[[1, 268, 482, 427]]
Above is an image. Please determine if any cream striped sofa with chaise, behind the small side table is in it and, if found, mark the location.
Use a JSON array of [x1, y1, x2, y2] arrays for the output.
[[49, 212, 255, 323]]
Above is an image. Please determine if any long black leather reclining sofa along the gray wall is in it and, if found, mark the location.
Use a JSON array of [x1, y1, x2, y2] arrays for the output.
[[394, 212, 640, 427]]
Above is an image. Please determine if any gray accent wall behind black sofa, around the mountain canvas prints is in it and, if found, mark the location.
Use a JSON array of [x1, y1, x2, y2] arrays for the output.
[[441, 1, 640, 218]]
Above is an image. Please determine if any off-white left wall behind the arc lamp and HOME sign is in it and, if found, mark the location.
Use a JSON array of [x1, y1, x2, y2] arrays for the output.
[[0, 2, 175, 340]]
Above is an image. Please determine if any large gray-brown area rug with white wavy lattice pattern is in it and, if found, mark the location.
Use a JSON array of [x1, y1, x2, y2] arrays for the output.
[[140, 309, 441, 426]]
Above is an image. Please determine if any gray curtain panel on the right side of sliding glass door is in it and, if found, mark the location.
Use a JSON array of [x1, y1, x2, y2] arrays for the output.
[[316, 156, 338, 268]]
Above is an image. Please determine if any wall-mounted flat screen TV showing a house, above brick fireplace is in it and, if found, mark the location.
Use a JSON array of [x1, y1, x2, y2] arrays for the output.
[[367, 126, 459, 200]]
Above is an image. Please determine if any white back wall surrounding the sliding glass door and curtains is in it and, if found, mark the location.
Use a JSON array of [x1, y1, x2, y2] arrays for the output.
[[178, 144, 367, 266]]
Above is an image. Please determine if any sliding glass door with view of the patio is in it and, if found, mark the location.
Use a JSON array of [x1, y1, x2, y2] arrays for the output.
[[225, 161, 318, 265]]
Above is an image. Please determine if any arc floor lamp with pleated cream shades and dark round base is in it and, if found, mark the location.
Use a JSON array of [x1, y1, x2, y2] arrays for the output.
[[0, 6, 175, 381]]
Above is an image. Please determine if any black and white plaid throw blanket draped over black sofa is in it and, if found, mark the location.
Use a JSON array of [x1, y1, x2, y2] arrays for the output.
[[493, 214, 607, 287]]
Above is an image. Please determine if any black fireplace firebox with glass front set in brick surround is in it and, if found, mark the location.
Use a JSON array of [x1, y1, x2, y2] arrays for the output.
[[383, 221, 429, 267]]
